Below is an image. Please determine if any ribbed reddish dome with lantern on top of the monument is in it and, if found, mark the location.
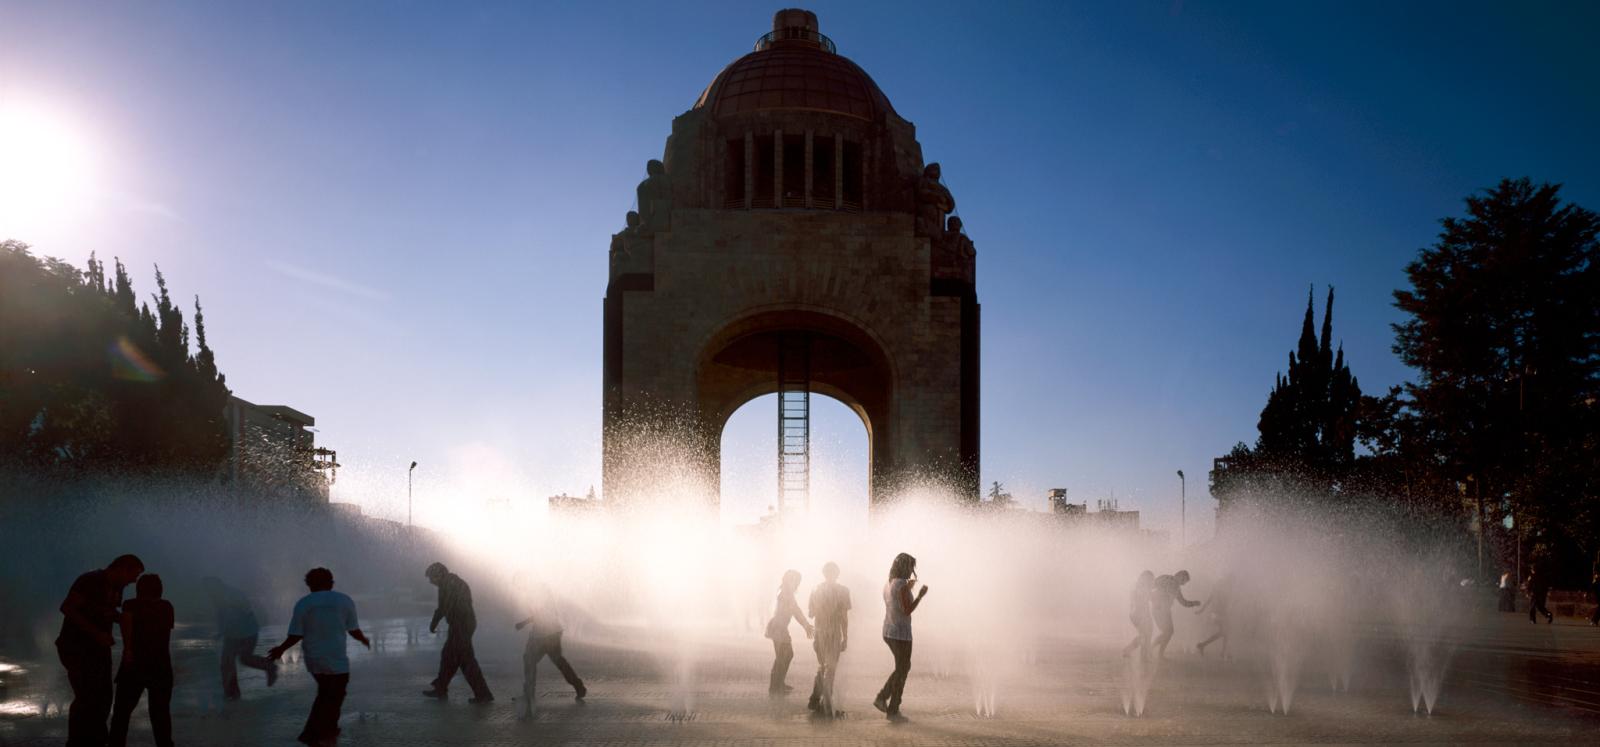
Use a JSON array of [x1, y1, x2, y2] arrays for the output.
[[694, 10, 894, 122]]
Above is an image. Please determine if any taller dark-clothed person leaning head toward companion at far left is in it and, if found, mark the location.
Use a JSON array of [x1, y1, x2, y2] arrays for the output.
[[56, 555, 144, 747]]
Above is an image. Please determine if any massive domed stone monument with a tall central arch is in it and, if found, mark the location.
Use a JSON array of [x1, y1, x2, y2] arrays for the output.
[[603, 10, 979, 509]]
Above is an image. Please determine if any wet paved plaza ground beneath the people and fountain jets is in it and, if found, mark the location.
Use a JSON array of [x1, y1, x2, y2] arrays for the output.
[[0, 613, 1600, 747]]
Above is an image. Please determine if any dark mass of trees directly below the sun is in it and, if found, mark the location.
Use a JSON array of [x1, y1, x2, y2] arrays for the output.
[[0, 242, 229, 475]]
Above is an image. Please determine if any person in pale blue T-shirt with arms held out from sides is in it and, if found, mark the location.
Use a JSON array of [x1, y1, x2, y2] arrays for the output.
[[267, 568, 373, 747]]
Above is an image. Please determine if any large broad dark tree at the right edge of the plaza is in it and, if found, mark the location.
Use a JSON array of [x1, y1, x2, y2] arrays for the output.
[[1394, 179, 1600, 569]]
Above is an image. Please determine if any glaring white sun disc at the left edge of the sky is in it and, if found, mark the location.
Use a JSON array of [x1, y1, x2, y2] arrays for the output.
[[0, 99, 94, 242]]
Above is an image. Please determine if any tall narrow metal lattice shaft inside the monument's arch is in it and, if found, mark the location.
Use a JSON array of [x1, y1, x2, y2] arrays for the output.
[[778, 333, 811, 517]]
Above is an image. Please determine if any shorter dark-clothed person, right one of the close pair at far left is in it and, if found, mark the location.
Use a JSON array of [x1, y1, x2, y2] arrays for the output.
[[107, 573, 173, 747]]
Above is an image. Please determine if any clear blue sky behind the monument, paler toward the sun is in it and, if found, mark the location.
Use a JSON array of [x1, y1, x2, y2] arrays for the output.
[[0, 0, 1600, 536]]
